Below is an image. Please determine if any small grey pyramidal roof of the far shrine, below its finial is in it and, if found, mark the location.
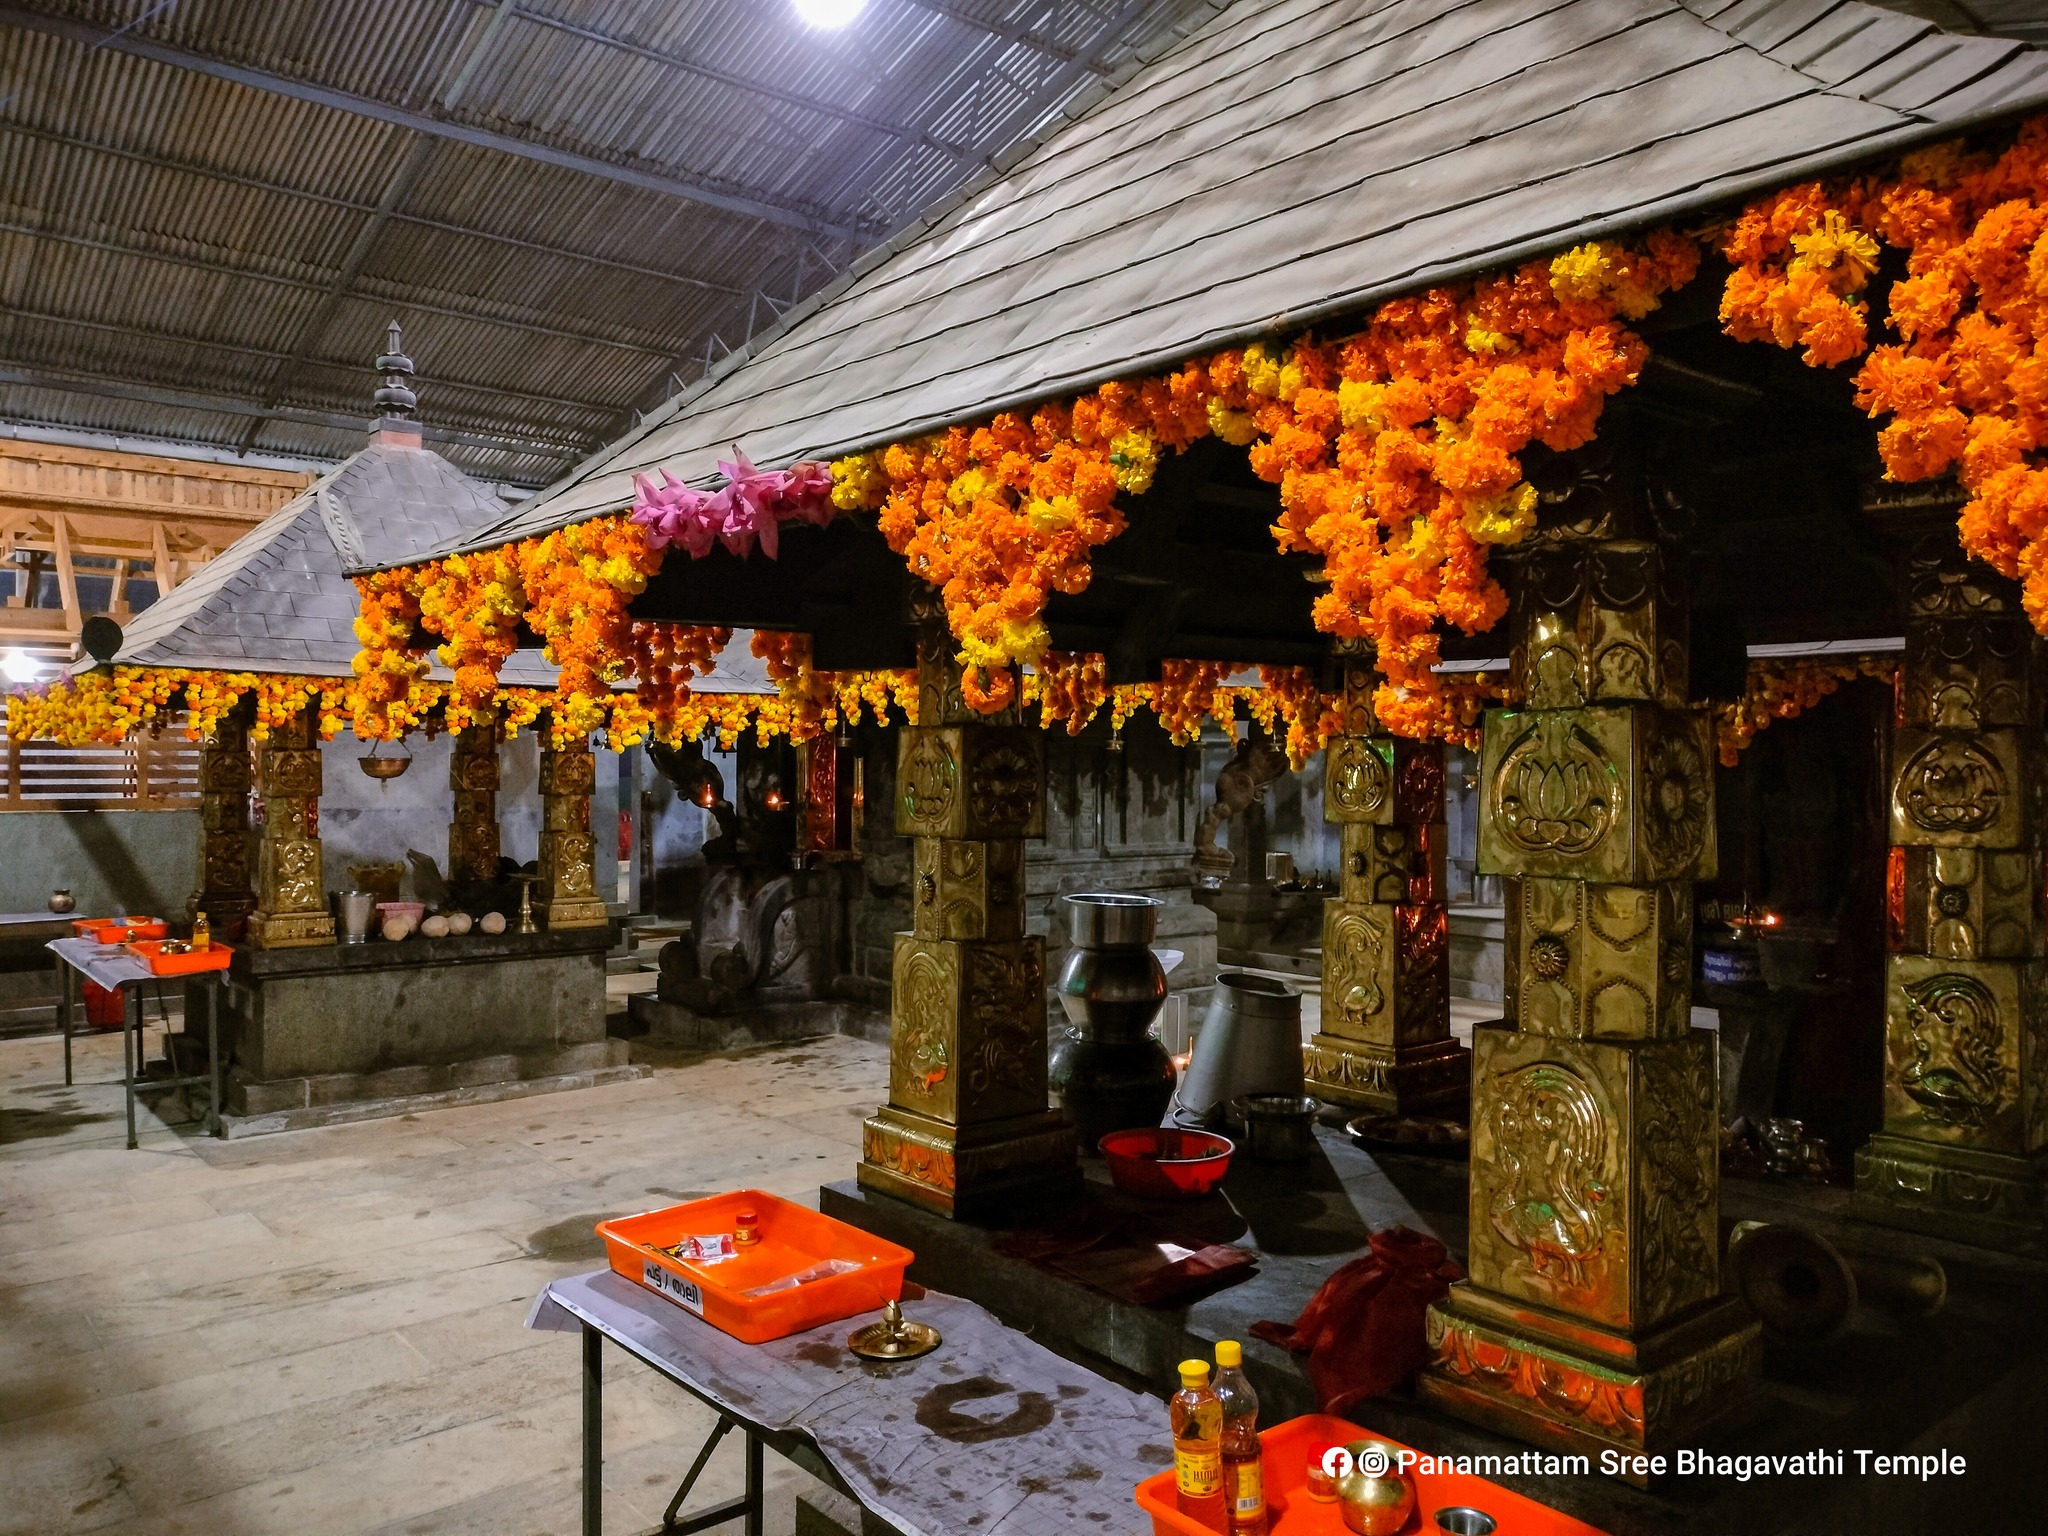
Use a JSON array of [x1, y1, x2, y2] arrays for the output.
[[115, 442, 532, 671]]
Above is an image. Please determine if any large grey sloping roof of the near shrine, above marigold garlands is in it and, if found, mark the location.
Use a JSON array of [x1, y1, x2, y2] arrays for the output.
[[411, 0, 2048, 561]]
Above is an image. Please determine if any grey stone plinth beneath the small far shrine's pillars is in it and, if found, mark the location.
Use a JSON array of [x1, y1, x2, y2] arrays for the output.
[[212, 928, 633, 1128]]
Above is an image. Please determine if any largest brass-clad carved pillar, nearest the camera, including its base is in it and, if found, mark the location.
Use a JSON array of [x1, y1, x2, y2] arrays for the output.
[[1421, 450, 1761, 1464]]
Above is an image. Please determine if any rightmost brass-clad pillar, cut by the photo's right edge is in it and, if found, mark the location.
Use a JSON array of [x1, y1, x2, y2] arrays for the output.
[[1853, 518, 2048, 1249]]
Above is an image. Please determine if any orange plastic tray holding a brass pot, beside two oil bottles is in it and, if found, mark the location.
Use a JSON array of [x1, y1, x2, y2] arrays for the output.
[[1139, 1407, 1604, 1536]]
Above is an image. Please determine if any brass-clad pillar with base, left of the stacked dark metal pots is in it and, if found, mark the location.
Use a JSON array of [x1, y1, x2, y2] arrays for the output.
[[860, 612, 1075, 1219]]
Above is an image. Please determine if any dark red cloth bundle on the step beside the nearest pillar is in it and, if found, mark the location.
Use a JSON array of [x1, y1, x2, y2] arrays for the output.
[[1251, 1227, 1464, 1417]]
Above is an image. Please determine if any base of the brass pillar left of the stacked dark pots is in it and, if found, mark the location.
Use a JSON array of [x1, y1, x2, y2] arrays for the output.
[[858, 1106, 1081, 1221]]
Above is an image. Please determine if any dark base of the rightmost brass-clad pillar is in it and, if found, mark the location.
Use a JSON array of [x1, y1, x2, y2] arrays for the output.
[[1849, 1133, 2048, 1253]]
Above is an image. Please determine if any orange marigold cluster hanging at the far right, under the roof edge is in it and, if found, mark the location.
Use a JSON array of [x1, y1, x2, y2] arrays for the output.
[[1720, 119, 2048, 633]]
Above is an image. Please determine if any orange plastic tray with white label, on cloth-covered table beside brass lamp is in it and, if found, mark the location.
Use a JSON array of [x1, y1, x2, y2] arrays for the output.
[[598, 1190, 911, 1343]]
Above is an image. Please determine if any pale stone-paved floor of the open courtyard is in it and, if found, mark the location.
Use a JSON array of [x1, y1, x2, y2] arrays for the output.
[[0, 1011, 887, 1536]]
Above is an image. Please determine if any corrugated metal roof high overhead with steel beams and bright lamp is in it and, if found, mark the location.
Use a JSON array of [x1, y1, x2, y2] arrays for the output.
[[0, 0, 1202, 485]]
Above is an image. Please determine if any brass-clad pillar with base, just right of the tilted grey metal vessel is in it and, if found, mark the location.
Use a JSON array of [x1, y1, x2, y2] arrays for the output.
[[1309, 641, 1470, 1114]]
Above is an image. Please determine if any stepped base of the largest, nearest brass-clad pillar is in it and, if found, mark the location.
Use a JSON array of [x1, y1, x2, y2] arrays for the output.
[[1419, 1280, 1763, 1483]]
